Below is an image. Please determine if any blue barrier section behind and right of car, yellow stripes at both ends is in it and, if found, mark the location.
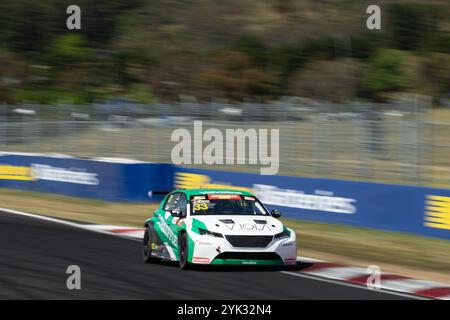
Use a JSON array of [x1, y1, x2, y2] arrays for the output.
[[175, 168, 450, 239]]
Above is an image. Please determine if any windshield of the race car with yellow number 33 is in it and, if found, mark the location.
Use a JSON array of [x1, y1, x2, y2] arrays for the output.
[[191, 194, 269, 216]]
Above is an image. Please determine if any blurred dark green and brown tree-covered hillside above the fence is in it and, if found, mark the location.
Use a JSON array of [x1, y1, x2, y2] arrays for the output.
[[0, 0, 450, 103]]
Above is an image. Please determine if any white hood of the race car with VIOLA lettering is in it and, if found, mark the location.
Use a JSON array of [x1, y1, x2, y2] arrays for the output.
[[192, 215, 283, 235]]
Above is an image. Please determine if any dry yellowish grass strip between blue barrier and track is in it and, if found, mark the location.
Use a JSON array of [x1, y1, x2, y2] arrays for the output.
[[0, 189, 450, 283]]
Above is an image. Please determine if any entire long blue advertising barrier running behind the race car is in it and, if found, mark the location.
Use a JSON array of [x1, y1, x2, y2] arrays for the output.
[[0, 154, 450, 239]]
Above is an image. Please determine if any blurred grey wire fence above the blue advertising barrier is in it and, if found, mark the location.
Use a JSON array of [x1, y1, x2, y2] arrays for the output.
[[0, 97, 450, 188]]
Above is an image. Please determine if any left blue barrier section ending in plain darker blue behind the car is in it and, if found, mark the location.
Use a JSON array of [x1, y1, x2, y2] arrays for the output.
[[0, 154, 173, 201]]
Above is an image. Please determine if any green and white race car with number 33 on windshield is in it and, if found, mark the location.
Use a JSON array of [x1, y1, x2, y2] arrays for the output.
[[143, 189, 297, 269]]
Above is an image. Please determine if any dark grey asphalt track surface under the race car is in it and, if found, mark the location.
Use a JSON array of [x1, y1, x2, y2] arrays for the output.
[[0, 212, 414, 300]]
